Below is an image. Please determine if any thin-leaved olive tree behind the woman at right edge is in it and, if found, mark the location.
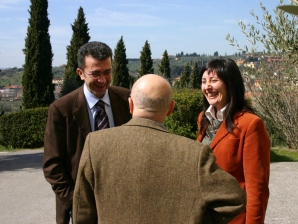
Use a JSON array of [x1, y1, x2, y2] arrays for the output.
[[226, 0, 298, 149]]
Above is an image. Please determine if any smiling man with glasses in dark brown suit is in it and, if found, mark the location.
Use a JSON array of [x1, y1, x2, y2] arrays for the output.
[[43, 42, 131, 224]]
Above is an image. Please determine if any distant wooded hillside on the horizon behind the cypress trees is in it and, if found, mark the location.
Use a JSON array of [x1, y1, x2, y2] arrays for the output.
[[0, 55, 244, 87]]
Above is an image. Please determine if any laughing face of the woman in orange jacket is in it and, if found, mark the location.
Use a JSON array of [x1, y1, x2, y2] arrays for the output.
[[201, 70, 228, 111]]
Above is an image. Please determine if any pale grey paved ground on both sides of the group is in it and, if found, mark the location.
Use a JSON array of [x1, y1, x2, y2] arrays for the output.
[[0, 149, 298, 224]]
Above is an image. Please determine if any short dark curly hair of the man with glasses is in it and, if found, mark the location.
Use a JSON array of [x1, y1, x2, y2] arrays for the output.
[[77, 41, 113, 69]]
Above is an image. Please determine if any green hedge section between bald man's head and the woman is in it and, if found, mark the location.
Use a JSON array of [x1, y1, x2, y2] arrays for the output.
[[165, 89, 203, 139]]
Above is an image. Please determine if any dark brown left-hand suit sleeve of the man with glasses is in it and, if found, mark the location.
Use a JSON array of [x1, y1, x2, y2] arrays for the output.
[[43, 104, 74, 209]]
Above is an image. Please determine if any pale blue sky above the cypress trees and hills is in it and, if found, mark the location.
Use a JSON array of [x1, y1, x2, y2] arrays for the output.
[[0, 0, 282, 68]]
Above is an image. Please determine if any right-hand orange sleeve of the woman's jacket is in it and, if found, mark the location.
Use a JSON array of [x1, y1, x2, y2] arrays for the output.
[[243, 117, 270, 224]]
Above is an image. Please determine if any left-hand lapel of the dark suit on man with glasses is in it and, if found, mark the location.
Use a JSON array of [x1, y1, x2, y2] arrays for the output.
[[73, 86, 91, 138]]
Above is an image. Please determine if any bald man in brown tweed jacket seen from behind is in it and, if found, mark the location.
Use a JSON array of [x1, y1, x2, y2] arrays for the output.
[[73, 74, 246, 224]]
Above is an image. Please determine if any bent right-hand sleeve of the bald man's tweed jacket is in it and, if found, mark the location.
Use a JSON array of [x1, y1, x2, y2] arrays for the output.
[[198, 146, 246, 224]]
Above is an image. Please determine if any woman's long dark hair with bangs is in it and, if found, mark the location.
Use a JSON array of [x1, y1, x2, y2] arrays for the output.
[[199, 58, 254, 133]]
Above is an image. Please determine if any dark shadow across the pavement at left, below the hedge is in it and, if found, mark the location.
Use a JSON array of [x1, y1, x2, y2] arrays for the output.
[[0, 152, 43, 172]]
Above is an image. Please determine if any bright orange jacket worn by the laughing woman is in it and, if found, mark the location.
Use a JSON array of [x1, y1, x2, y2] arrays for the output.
[[197, 112, 270, 224]]
